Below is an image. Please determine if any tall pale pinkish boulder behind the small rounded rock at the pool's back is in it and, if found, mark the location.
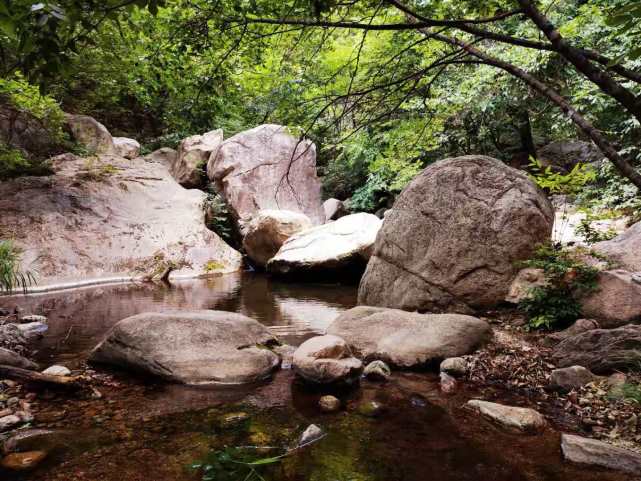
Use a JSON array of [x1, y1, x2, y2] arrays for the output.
[[207, 125, 325, 224]]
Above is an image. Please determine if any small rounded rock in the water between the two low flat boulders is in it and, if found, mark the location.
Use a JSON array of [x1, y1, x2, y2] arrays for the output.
[[293, 336, 363, 384]]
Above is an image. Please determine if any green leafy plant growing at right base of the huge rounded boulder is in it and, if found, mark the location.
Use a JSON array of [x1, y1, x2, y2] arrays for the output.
[[519, 244, 598, 329]]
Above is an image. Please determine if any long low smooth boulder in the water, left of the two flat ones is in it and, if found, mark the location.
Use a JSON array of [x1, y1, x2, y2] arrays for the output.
[[90, 310, 280, 384]]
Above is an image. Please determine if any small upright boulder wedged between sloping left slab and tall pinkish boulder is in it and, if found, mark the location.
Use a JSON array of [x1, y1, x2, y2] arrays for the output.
[[171, 129, 223, 189]]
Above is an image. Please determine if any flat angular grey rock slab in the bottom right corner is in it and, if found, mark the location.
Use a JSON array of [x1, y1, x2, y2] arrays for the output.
[[561, 434, 641, 475]]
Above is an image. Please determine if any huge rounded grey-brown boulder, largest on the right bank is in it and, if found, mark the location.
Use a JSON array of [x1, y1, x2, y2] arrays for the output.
[[358, 155, 554, 312]]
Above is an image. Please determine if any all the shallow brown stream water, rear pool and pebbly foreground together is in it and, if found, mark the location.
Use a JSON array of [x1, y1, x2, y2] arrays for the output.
[[0, 273, 630, 481]]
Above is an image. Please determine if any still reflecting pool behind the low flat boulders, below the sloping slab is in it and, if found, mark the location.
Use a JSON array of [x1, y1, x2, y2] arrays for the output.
[[0, 273, 356, 365]]
